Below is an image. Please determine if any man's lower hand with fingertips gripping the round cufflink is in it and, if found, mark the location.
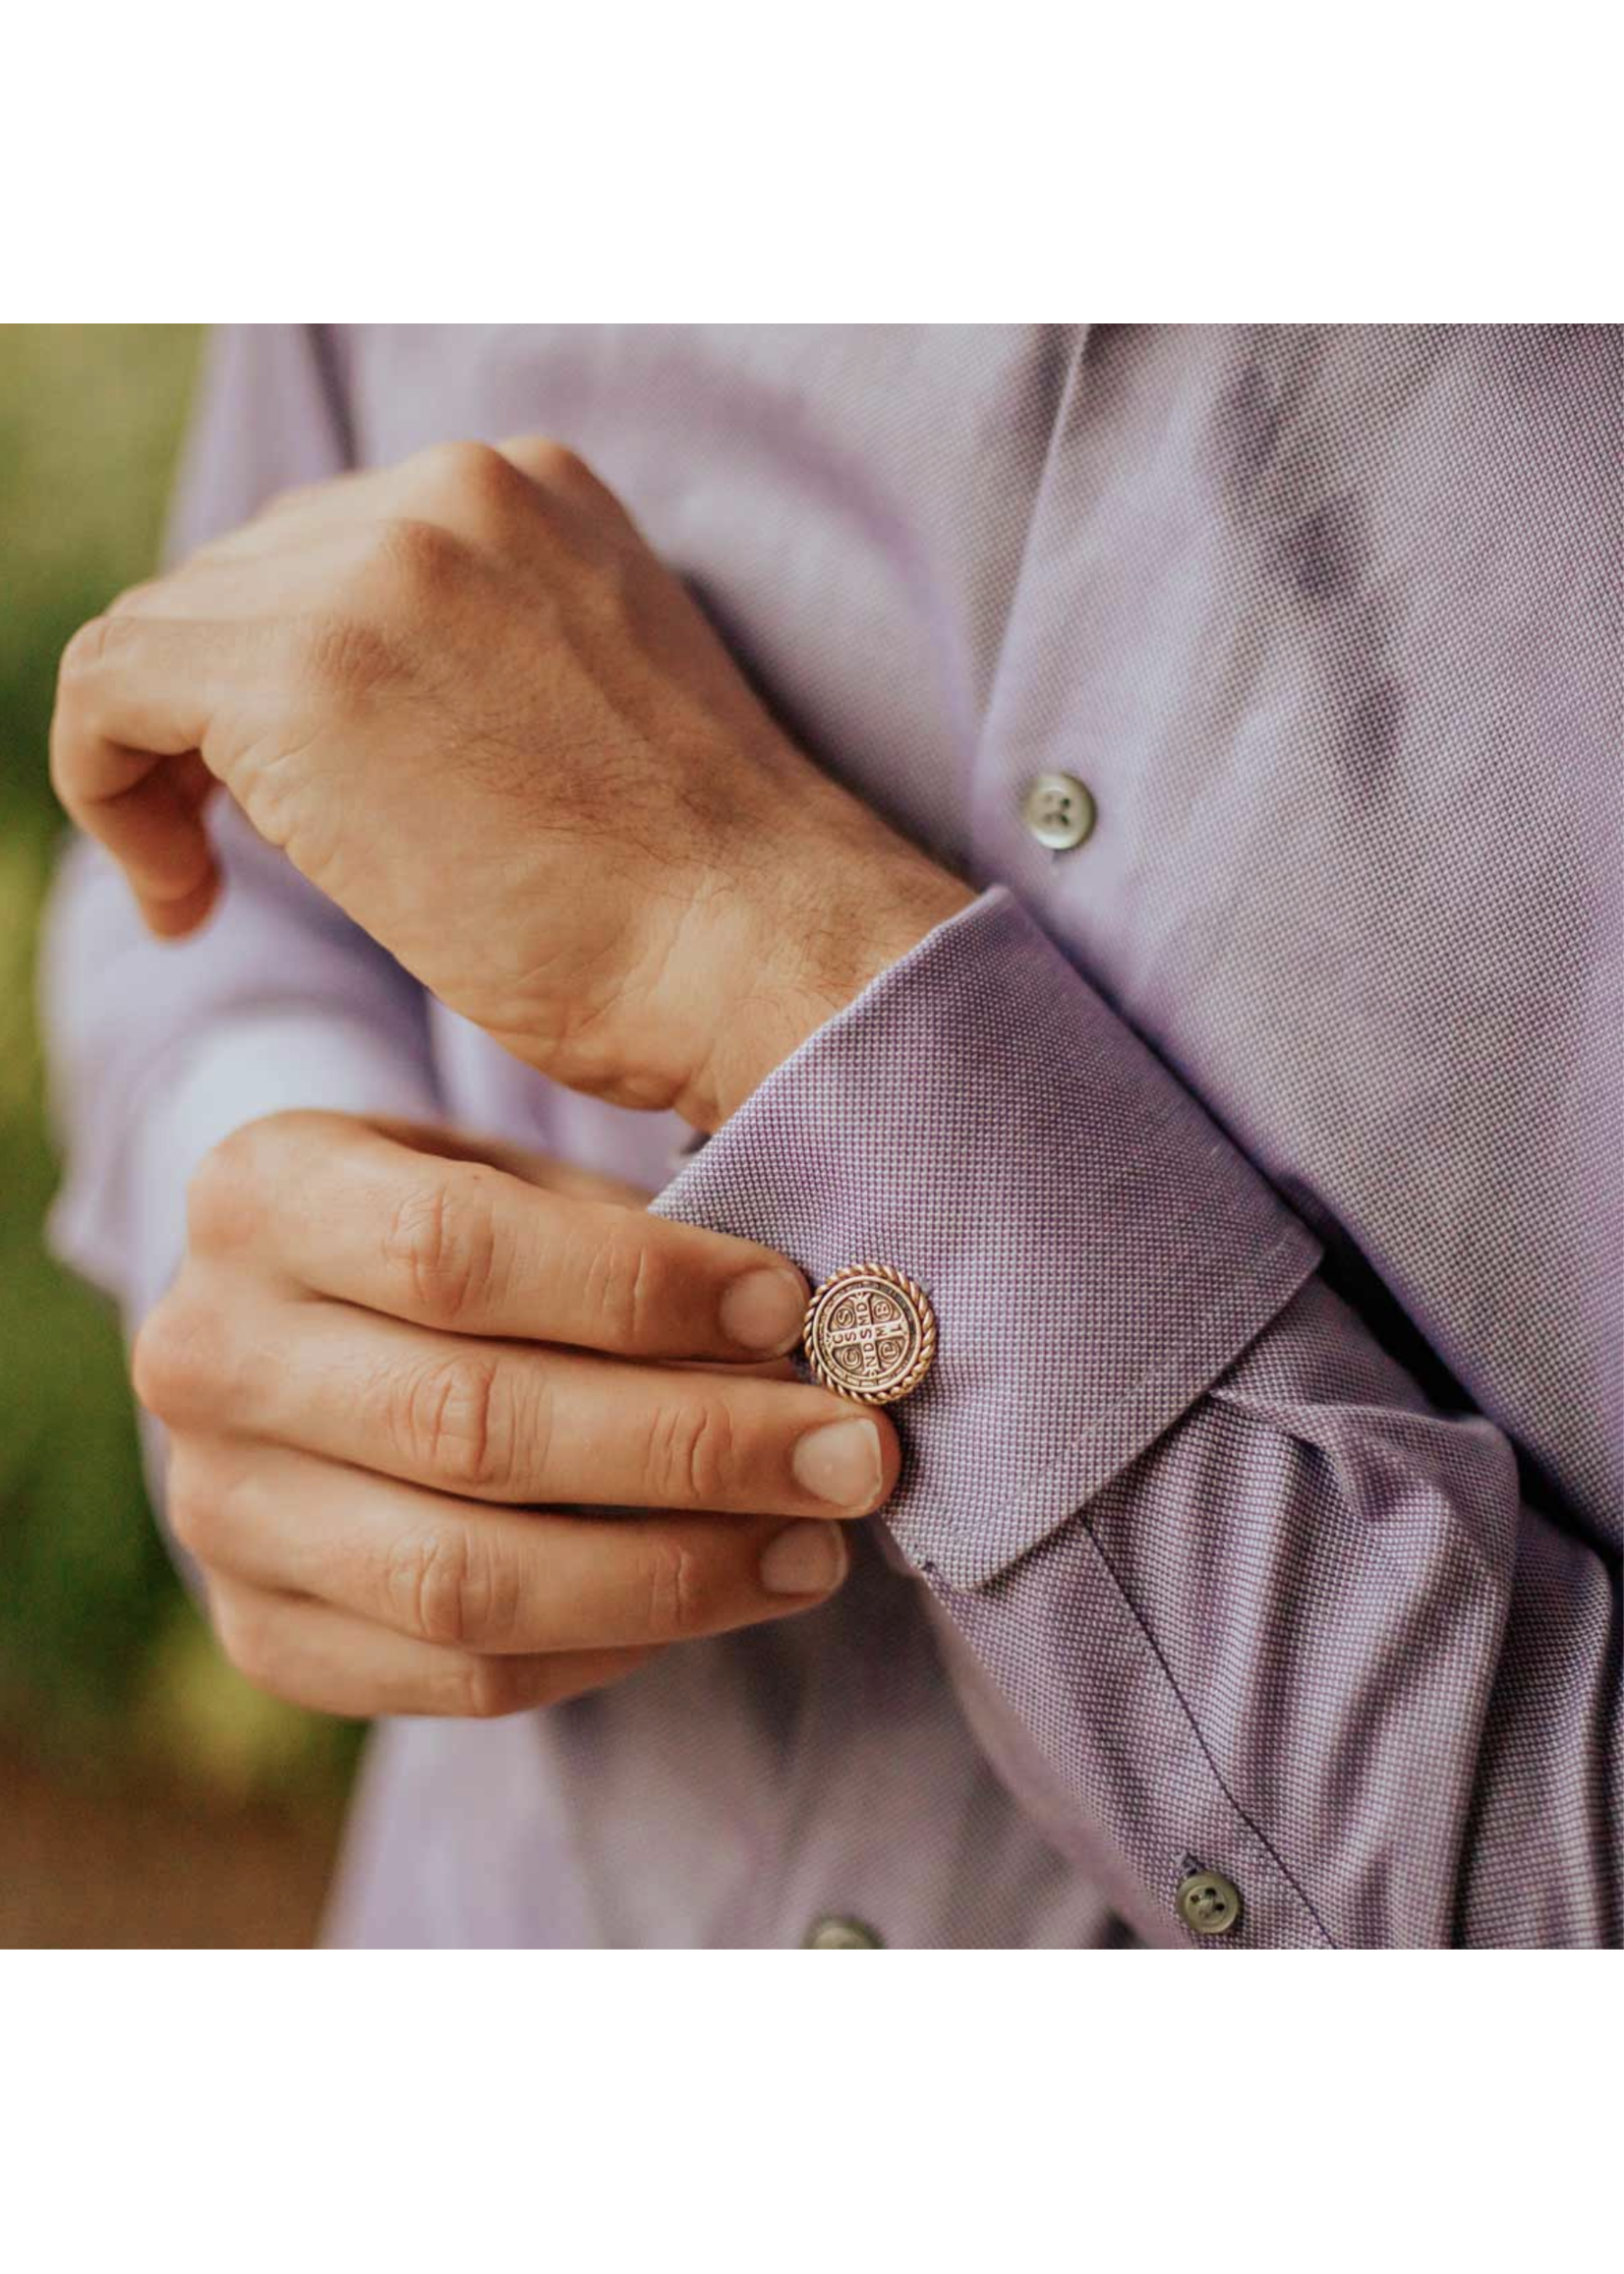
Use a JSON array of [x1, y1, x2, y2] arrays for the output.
[[135, 1114, 899, 1715]]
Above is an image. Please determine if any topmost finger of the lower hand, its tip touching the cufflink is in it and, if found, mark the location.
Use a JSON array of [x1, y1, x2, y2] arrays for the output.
[[191, 1114, 807, 1360]]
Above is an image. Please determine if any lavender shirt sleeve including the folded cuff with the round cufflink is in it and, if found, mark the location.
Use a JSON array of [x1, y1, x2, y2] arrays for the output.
[[658, 889, 1619, 1949]]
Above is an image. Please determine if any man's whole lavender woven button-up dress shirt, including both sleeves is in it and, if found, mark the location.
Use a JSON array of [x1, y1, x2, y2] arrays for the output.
[[48, 325, 1624, 1949]]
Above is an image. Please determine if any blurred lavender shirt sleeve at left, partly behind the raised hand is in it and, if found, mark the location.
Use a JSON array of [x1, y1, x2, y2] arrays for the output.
[[41, 325, 436, 1473]]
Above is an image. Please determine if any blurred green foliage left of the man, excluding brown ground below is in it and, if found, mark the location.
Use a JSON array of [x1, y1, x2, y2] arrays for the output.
[[0, 322, 353, 1796]]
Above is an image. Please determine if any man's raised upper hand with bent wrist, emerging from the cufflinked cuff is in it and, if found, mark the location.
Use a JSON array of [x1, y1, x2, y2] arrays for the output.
[[52, 441, 971, 1128]]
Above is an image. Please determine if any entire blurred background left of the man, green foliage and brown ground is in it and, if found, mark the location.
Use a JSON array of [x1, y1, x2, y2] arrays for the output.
[[0, 322, 357, 1949]]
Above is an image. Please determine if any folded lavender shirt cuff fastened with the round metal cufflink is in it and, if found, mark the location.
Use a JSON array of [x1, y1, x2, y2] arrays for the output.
[[655, 887, 1319, 1587]]
